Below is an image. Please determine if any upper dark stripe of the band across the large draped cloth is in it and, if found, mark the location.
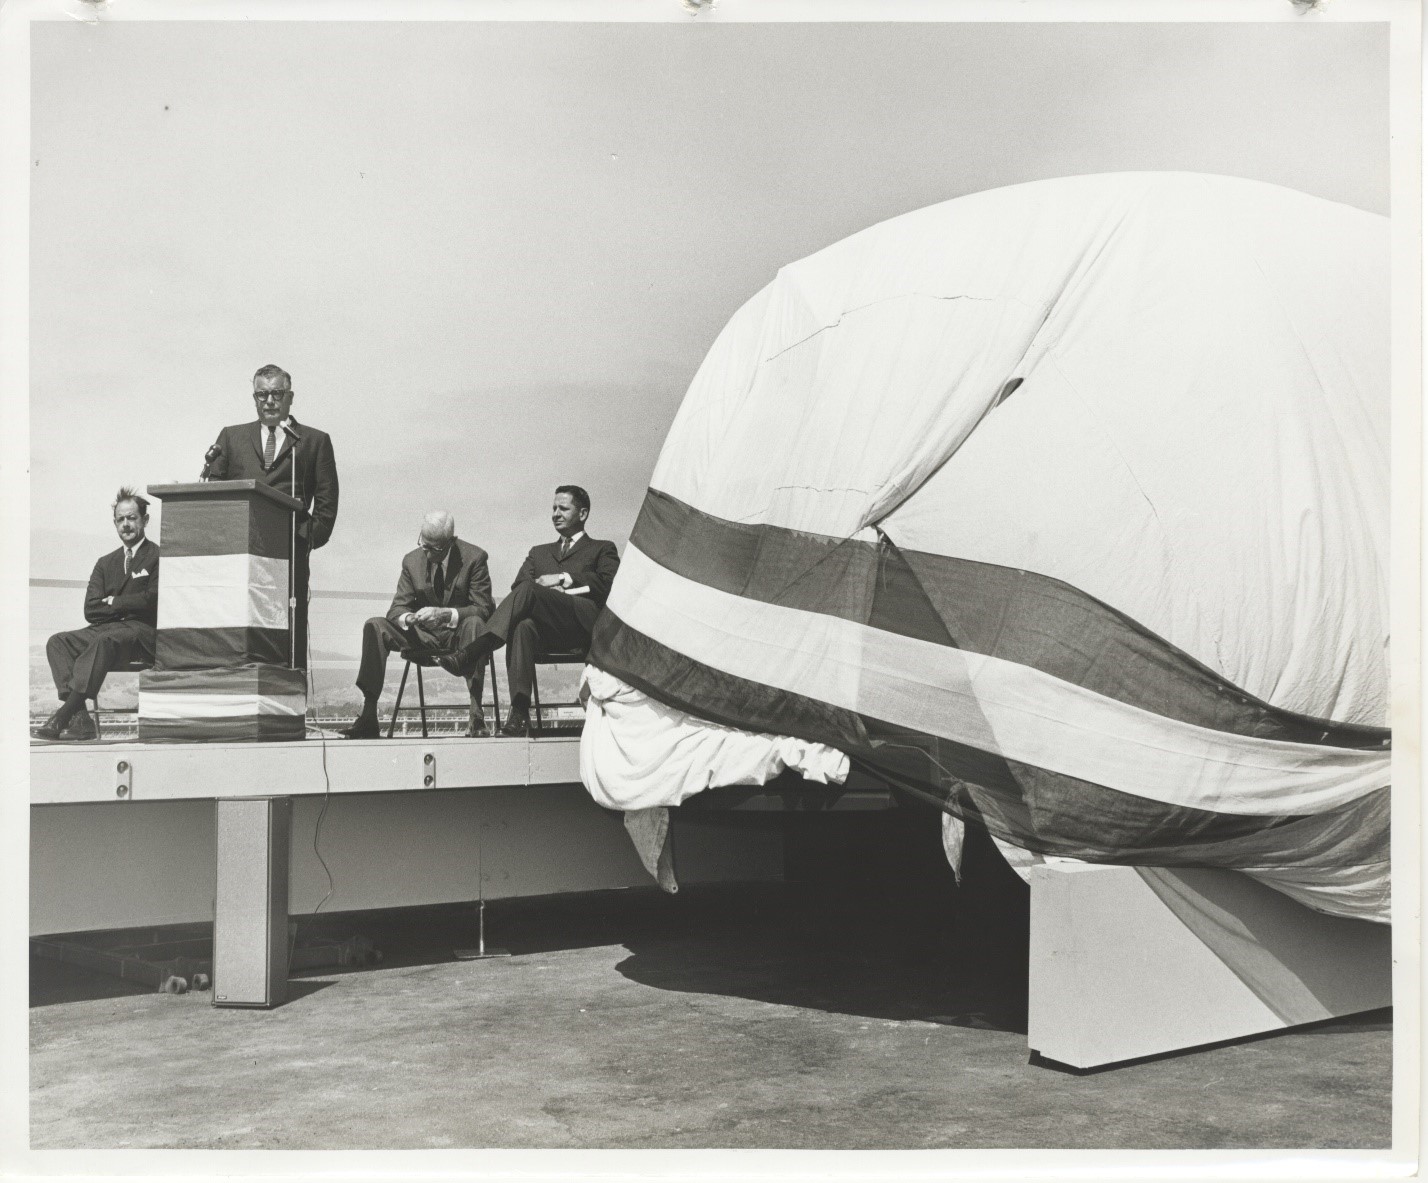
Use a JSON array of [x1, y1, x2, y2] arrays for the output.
[[630, 489, 1388, 747]]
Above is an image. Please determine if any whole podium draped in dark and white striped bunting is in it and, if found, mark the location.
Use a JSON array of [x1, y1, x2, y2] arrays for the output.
[[139, 480, 307, 743]]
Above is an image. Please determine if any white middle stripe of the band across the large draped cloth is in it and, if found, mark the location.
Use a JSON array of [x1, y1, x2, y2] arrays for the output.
[[608, 541, 1388, 814]]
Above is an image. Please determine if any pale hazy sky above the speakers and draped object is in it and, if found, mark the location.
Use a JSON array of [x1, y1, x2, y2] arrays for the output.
[[30, 20, 1388, 622]]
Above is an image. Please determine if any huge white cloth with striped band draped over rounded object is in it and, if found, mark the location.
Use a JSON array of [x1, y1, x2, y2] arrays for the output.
[[583, 173, 1389, 920]]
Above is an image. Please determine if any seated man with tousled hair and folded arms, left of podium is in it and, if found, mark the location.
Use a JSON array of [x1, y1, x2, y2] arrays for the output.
[[33, 486, 159, 740]]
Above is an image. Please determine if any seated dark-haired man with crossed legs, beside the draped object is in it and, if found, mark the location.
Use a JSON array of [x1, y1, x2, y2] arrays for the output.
[[440, 484, 620, 736]]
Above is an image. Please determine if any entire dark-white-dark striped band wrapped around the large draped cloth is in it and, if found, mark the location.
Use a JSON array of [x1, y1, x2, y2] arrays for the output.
[[590, 490, 1389, 920]]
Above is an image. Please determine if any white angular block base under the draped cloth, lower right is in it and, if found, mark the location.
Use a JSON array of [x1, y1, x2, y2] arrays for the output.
[[1027, 864, 1392, 1067]]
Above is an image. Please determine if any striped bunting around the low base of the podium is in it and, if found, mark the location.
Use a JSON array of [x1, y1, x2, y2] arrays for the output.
[[139, 665, 307, 743]]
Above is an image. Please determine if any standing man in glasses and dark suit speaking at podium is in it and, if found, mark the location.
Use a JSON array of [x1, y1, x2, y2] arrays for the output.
[[203, 366, 337, 669]]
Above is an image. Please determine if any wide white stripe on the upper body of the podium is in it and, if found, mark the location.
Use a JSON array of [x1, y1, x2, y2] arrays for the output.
[[159, 551, 288, 632]]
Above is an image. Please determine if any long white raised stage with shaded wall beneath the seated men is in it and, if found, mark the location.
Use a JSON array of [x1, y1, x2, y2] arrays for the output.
[[30, 737, 783, 936]]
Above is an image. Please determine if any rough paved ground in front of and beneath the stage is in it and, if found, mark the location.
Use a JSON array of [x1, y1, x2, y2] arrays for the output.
[[31, 886, 1391, 1149]]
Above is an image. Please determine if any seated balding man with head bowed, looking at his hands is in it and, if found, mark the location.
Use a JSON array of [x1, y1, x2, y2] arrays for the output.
[[343, 510, 494, 739]]
